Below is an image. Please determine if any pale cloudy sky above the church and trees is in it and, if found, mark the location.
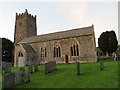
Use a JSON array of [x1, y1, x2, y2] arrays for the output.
[[0, 1, 120, 45]]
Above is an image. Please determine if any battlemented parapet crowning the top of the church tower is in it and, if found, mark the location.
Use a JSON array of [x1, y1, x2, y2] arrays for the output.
[[16, 9, 36, 20]]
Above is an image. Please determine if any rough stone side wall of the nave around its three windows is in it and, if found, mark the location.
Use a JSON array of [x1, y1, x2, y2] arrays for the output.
[[31, 35, 97, 64]]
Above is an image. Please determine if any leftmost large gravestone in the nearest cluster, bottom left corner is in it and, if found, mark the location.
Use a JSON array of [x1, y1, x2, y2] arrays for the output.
[[4, 73, 15, 88]]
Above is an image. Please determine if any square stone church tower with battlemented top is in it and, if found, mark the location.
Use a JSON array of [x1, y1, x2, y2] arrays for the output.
[[14, 9, 37, 44]]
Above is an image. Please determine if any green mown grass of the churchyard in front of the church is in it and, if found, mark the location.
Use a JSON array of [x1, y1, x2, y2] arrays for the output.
[[12, 61, 118, 88]]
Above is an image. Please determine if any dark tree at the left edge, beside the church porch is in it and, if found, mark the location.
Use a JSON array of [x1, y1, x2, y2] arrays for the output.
[[2, 38, 13, 63]]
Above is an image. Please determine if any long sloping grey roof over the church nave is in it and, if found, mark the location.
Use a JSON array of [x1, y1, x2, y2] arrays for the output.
[[18, 25, 94, 44]]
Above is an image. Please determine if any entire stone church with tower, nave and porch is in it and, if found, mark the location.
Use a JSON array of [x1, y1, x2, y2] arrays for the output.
[[14, 10, 97, 67]]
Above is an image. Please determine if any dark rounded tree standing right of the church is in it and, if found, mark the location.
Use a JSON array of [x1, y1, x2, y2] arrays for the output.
[[98, 31, 118, 55]]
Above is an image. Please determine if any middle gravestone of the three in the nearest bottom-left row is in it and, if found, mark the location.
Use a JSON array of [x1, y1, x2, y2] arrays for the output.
[[15, 70, 24, 85]]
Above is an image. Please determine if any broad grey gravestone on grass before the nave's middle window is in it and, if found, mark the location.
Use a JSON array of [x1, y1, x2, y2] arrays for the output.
[[45, 61, 56, 74]]
